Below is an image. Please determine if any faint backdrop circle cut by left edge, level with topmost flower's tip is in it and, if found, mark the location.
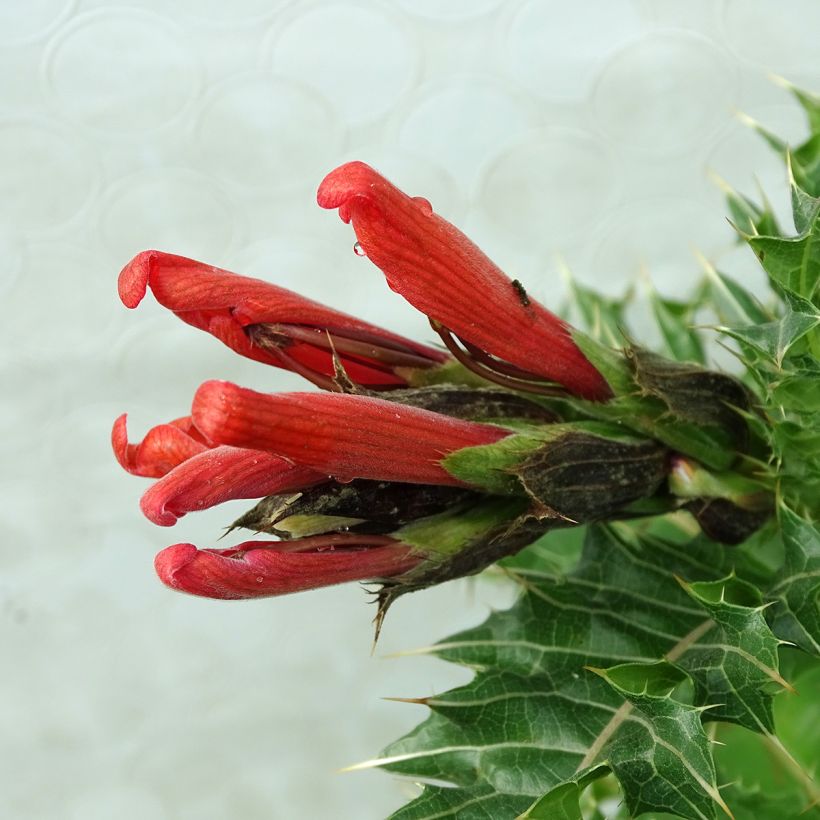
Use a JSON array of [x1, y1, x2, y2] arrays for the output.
[[0, 121, 98, 230]]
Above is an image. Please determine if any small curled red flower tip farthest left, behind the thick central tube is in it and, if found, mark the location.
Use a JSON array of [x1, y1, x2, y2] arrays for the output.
[[111, 413, 210, 478]]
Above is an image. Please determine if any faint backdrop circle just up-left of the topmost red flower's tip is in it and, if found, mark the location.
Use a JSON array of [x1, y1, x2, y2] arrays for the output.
[[196, 73, 340, 189]]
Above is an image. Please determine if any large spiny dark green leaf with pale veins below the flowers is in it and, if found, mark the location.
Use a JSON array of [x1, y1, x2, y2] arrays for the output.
[[372, 527, 777, 818]]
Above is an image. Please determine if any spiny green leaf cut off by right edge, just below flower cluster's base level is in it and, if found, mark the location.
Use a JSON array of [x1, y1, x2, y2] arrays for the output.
[[768, 506, 820, 655]]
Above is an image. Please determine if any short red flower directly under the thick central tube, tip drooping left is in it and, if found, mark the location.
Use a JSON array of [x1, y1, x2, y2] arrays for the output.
[[140, 447, 325, 527]]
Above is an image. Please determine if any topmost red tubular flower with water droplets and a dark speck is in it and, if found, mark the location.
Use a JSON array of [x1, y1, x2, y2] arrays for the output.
[[317, 162, 612, 401]]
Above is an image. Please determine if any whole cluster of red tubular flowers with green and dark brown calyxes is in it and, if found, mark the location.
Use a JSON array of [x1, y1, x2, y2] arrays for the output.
[[112, 162, 764, 616]]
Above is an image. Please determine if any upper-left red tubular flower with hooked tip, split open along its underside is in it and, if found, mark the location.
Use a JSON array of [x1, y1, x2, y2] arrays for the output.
[[118, 251, 449, 386]]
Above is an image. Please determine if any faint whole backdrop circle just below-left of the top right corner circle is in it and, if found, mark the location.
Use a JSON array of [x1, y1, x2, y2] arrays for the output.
[[593, 33, 734, 156]]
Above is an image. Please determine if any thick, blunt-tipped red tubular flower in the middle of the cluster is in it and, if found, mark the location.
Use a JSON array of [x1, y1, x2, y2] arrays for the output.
[[191, 381, 510, 486]]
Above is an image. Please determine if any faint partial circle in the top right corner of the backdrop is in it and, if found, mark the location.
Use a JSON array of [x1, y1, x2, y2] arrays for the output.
[[723, 0, 820, 78]]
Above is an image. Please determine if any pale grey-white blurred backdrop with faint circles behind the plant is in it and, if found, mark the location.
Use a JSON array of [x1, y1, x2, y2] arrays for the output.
[[0, 0, 820, 820]]
